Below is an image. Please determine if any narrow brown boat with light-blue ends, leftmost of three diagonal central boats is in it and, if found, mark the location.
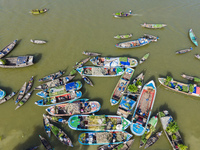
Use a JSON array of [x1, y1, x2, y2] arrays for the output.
[[110, 68, 135, 105]]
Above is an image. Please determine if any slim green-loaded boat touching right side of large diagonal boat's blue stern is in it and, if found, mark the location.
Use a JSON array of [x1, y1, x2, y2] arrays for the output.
[[139, 116, 158, 148]]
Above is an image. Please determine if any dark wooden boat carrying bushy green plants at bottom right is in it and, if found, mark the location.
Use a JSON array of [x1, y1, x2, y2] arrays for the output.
[[158, 110, 183, 150]]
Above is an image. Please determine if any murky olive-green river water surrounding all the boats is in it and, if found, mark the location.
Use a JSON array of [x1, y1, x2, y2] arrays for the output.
[[0, 0, 200, 150]]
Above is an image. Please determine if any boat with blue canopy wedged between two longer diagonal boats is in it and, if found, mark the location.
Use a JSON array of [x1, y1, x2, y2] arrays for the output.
[[117, 73, 144, 118]]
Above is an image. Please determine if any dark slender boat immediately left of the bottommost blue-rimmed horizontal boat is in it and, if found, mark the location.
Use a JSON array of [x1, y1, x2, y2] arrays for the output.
[[49, 124, 73, 147]]
